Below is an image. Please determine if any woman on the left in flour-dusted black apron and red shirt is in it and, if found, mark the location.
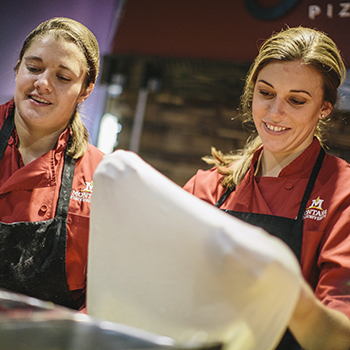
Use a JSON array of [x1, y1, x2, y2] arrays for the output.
[[0, 18, 103, 309]]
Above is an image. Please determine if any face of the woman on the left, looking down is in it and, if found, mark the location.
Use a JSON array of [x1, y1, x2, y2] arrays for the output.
[[14, 35, 93, 133]]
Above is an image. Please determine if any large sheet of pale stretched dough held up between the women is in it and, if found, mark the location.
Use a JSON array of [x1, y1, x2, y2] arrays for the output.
[[87, 150, 301, 350]]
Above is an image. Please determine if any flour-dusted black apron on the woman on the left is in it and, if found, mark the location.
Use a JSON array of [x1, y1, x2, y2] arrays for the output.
[[0, 108, 78, 309]]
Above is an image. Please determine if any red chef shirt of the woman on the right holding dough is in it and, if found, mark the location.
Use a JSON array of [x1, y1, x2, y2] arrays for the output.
[[184, 139, 350, 318]]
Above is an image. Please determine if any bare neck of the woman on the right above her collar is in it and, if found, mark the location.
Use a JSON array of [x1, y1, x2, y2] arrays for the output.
[[258, 149, 304, 177]]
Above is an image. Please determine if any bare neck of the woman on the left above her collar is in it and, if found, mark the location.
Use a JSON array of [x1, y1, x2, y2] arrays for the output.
[[15, 118, 63, 165]]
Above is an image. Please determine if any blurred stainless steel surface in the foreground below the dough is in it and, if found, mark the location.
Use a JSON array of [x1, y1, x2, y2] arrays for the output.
[[0, 290, 220, 350]]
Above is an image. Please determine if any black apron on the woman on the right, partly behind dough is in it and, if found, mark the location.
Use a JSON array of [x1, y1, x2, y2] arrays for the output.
[[215, 148, 325, 350]]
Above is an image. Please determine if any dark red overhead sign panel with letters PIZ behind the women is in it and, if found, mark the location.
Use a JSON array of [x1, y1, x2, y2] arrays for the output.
[[114, 0, 350, 67]]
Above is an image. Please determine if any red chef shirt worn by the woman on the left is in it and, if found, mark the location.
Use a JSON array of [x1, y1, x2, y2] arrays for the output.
[[0, 101, 103, 305]]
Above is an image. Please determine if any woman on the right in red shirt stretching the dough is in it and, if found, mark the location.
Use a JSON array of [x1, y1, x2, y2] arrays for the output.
[[185, 27, 350, 350]]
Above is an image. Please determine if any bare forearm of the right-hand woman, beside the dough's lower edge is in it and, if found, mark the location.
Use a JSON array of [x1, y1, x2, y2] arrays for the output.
[[289, 282, 350, 350]]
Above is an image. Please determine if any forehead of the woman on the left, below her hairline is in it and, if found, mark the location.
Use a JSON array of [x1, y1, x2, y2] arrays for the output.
[[23, 34, 87, 70]]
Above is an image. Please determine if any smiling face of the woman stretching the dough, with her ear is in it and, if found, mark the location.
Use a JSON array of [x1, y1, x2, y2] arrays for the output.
[[252, 61, 332, 157]]
